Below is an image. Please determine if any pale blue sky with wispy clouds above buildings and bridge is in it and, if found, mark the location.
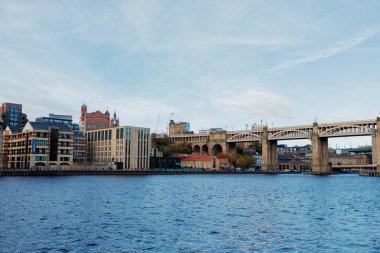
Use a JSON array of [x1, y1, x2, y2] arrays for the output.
[[0, 0, 380, 147]]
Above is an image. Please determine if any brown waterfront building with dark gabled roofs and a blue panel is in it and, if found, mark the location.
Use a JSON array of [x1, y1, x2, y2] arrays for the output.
[[3, 122, 74, 169]]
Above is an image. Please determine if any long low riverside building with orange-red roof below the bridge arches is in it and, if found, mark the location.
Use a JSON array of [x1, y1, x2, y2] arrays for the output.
[[181, 153, 231, 170]]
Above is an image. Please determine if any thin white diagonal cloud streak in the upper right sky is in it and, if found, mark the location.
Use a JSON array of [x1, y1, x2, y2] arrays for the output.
[[274, 27, 380, 70]]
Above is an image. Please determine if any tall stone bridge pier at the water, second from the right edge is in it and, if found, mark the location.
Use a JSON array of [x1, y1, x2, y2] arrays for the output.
[[311, 123, 331, 175]]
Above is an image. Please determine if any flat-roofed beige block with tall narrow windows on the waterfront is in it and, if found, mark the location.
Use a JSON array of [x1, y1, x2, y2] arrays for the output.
[[85, 126, 151, 170]]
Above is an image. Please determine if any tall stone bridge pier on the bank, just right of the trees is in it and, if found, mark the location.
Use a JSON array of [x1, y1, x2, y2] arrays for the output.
[[261, 127, 277, 172]]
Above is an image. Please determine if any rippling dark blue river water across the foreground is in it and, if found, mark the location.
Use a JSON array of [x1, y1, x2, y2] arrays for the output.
[[0, 175, 380, 252]]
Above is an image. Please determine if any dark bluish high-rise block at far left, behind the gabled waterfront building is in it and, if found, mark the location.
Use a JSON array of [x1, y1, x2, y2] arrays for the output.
[[0, 103, 28, 131]]
